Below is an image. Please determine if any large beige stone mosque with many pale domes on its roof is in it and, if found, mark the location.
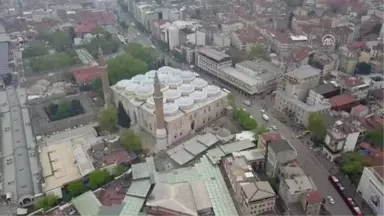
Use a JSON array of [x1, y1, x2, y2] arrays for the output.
[[111, 67, 228, 148]]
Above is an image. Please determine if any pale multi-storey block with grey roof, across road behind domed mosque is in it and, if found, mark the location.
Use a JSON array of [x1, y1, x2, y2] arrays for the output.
[[195, 47, 232, 76]]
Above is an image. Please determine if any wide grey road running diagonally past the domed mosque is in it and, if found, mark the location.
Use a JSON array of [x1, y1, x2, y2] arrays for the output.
[[115, 4, 353, 216]]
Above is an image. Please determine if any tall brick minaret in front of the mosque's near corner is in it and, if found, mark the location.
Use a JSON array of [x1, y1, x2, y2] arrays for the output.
[[153, 72, 168, 151]]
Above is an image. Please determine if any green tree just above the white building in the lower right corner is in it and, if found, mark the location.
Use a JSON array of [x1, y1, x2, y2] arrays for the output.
[[341, 152, 370, 185]]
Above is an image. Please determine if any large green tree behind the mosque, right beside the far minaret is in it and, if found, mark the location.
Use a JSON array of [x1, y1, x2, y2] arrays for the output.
[[107, 54, 147, 85]]
